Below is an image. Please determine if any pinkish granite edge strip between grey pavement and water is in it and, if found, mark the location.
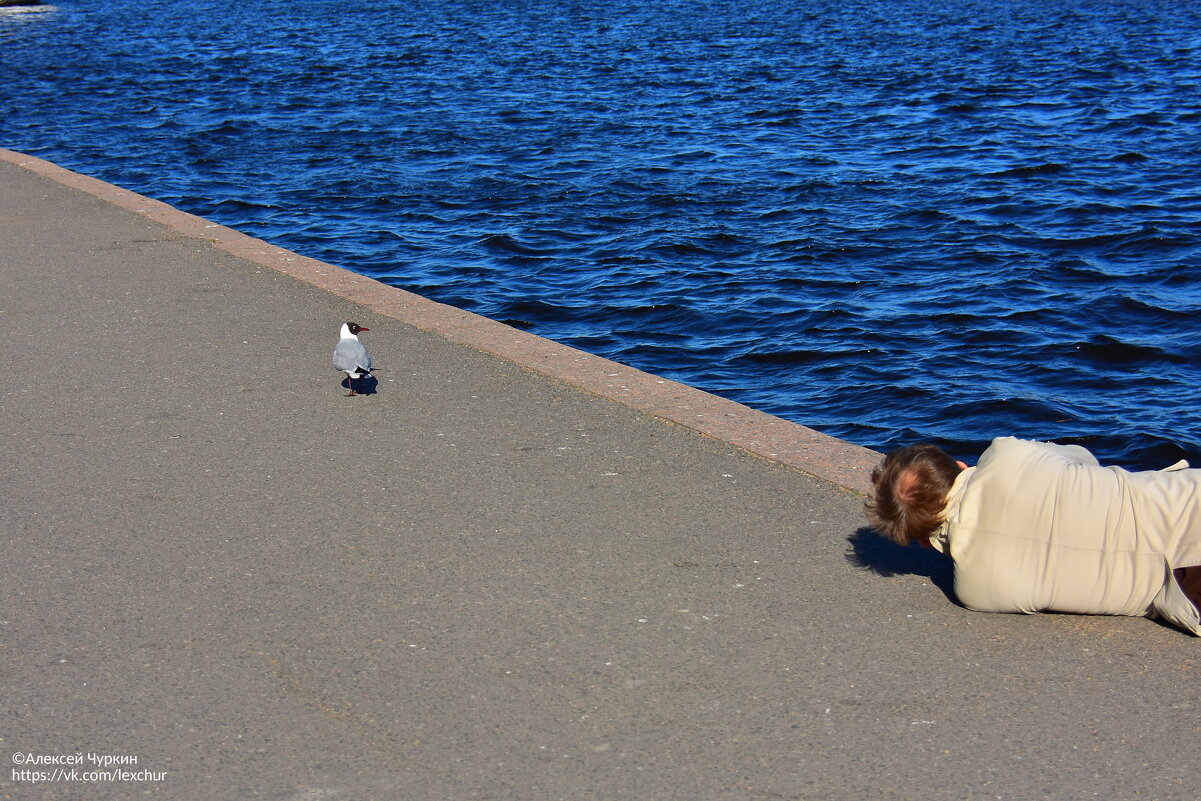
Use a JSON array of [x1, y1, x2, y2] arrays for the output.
[[0, 149, 880, 495]]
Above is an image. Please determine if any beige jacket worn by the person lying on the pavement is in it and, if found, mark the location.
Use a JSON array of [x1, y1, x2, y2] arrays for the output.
[[931, 437, 1201, 634]]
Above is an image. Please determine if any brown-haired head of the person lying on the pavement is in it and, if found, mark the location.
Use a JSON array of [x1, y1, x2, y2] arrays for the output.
[[867, 443, 963, 545]]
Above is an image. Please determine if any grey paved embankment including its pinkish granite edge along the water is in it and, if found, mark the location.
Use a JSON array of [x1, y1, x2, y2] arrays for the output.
[[0, 151, 1201, 801]]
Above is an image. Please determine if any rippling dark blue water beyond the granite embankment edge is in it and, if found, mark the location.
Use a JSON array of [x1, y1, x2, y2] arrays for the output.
[[7, 0, 1201, 467]]
